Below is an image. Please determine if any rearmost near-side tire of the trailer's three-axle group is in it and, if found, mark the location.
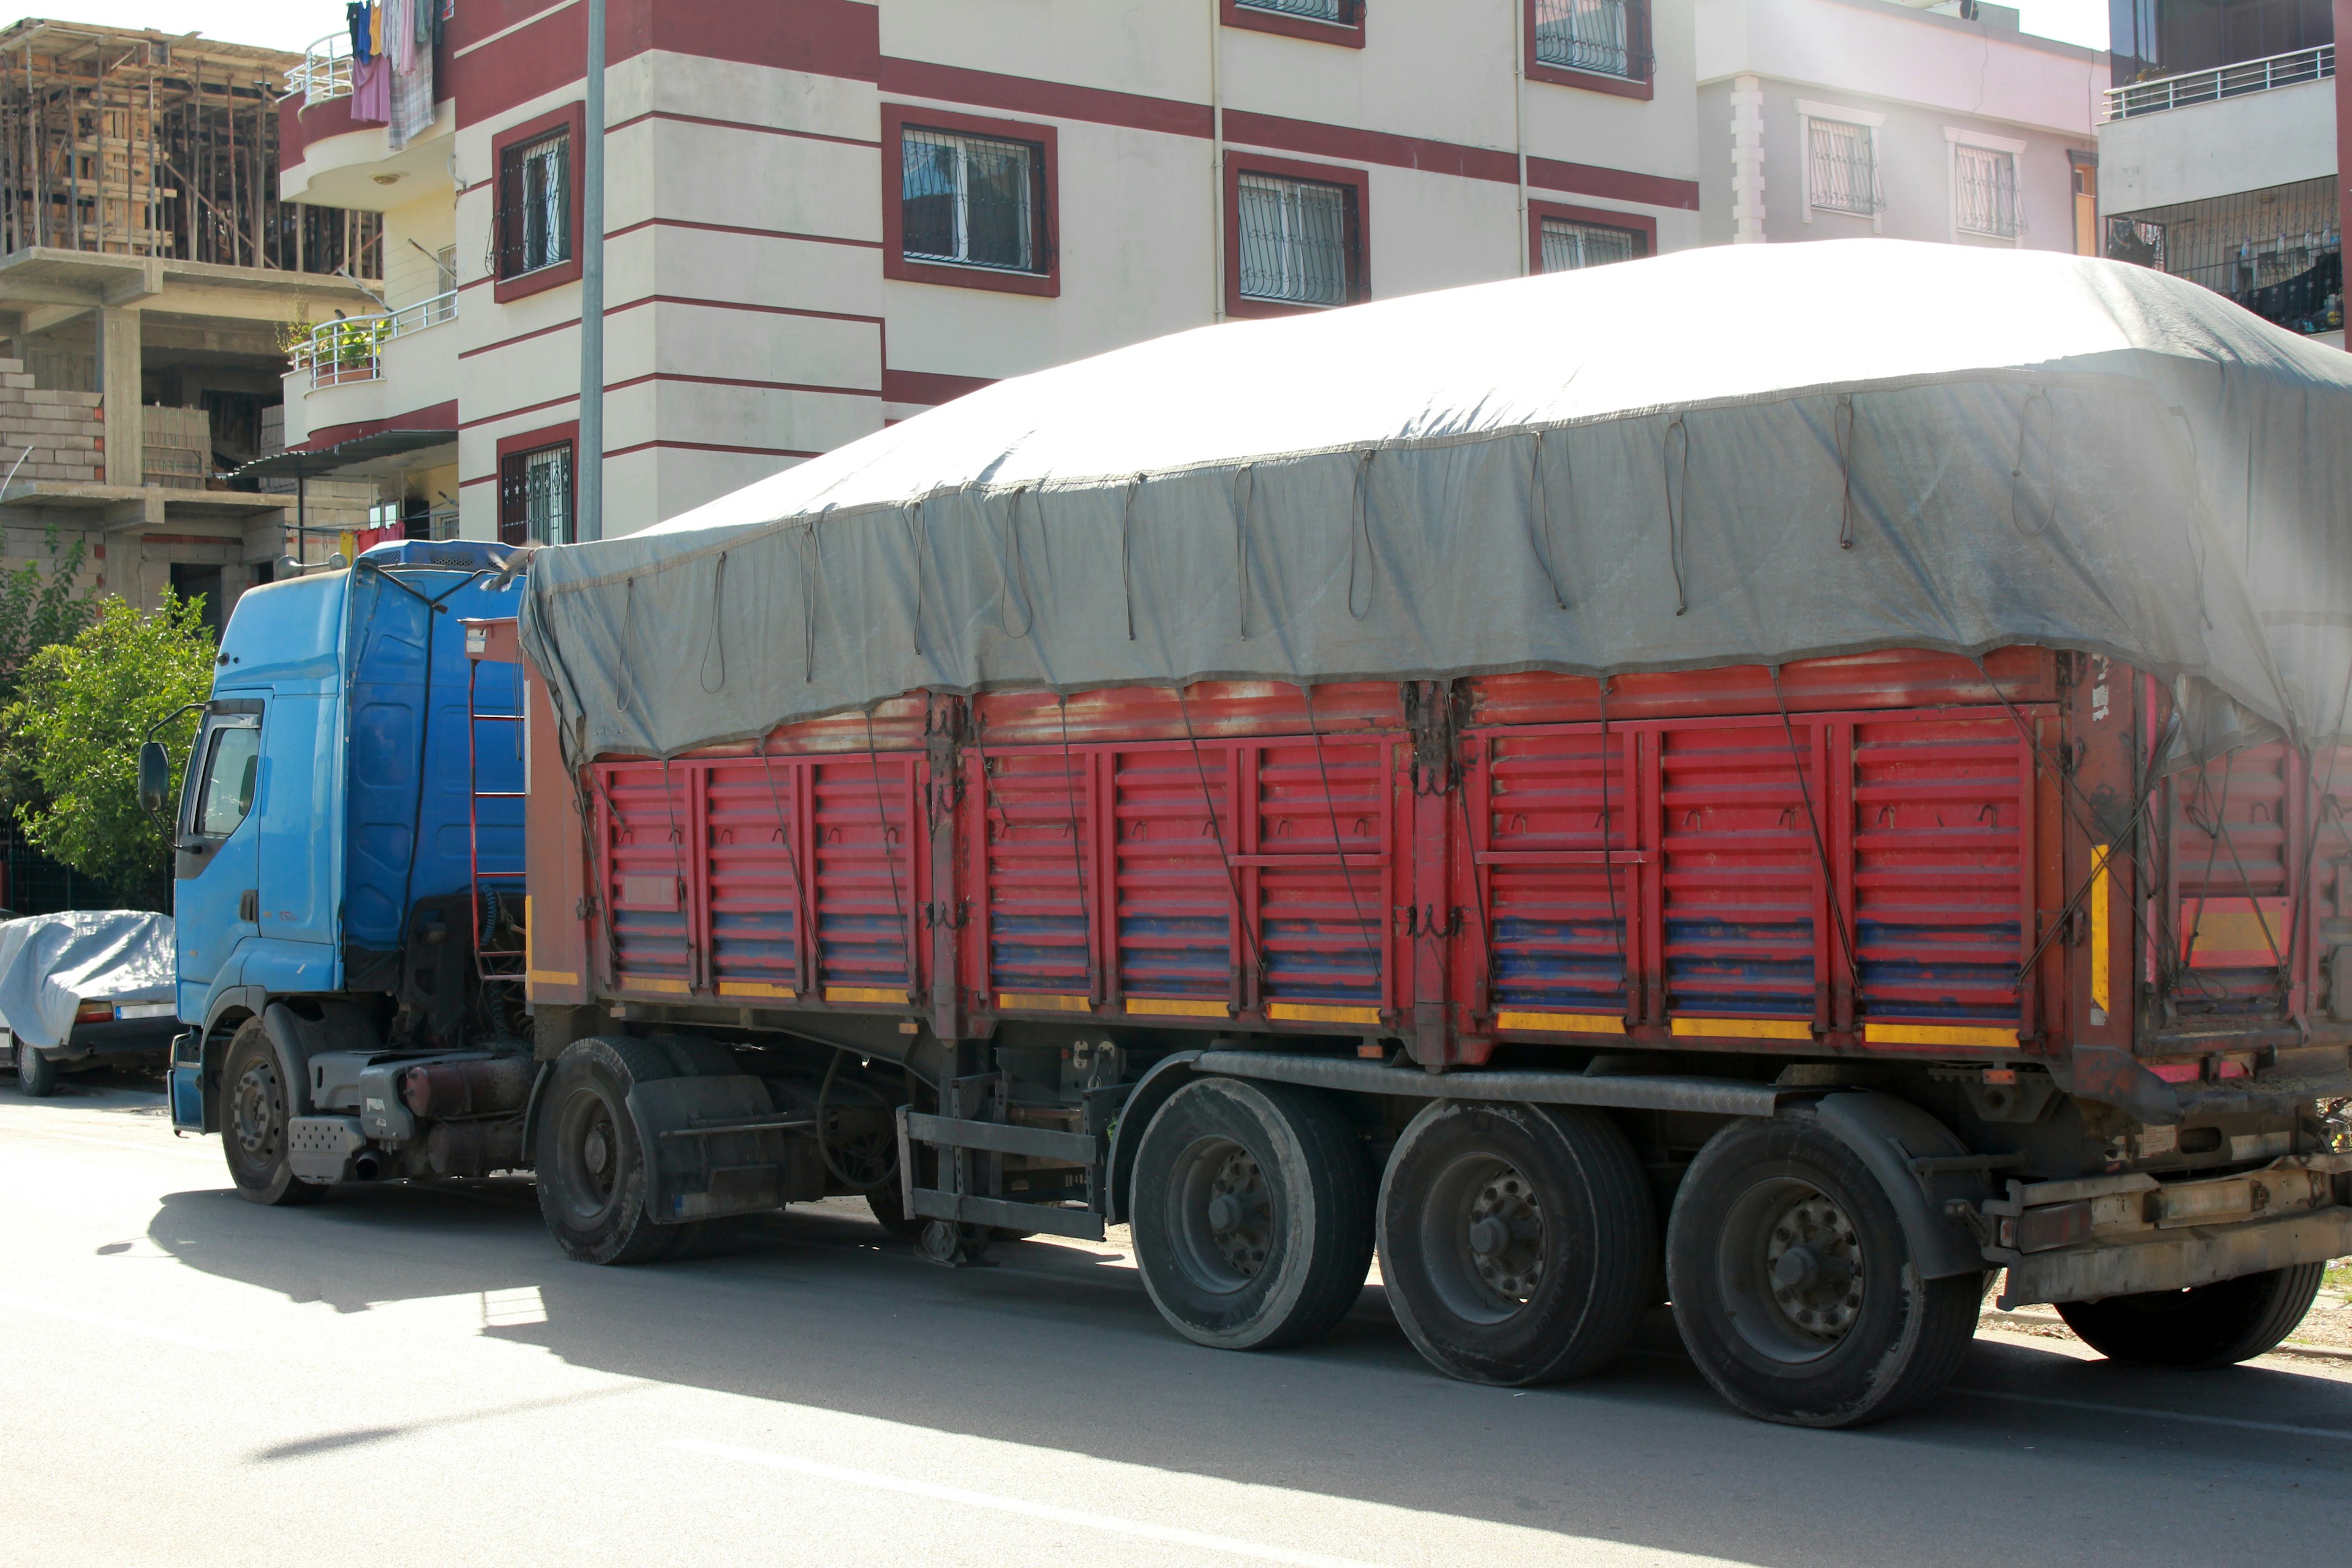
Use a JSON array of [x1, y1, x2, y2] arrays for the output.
[[1665, 1112, 1985, 1427]]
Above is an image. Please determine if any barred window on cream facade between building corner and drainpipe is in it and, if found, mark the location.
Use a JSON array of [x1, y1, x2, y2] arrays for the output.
[[899, 124, 1044, 273]]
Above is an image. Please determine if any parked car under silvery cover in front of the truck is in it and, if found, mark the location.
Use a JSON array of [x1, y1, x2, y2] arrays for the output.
[[0, 910, 179, 1096]]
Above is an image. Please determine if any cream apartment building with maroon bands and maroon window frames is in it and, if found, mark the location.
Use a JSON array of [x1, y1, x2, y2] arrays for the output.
[[280, 0, 1703, 541]]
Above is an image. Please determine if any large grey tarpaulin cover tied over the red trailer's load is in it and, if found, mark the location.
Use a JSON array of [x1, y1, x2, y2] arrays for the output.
[[522, 239, 2352, 760]]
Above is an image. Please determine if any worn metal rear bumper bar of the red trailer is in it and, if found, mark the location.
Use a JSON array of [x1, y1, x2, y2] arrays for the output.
[[1999, 1204, 2352, 1312]]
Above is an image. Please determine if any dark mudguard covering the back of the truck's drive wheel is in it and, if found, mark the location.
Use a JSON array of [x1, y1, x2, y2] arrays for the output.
[[628, 1074, 826, 1225]]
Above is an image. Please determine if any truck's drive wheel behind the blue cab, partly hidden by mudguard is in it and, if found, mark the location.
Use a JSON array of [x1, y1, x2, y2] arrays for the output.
[[534, 1035, 696, 1262]]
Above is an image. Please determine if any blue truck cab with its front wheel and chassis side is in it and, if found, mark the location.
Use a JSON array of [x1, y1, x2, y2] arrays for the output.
[[172, 541, 529, 1204]]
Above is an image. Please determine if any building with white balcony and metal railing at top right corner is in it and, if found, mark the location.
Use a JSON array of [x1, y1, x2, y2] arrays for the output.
[[2098, 0, 2352, 348]]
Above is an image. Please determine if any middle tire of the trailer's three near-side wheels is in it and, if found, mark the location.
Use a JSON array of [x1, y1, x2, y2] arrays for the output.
[[1381, 1100, 1658, 1387]]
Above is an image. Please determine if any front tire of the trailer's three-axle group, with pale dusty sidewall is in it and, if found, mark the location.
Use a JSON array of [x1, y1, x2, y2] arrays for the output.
[[1131, 1079, 1374, 1349]]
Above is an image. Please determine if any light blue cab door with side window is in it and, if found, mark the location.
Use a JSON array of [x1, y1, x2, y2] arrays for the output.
[[172, 698, 261, 1018]]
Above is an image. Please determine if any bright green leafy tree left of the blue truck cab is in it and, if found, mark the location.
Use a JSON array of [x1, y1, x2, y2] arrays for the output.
[[0, 592, 214, 898]]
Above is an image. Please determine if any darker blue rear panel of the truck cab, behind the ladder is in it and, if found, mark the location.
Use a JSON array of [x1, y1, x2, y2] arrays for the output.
[[344, 566, 522, 952]]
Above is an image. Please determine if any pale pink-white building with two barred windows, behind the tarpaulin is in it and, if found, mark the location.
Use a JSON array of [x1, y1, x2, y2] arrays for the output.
[[1696, 0, 2105, 254]]
